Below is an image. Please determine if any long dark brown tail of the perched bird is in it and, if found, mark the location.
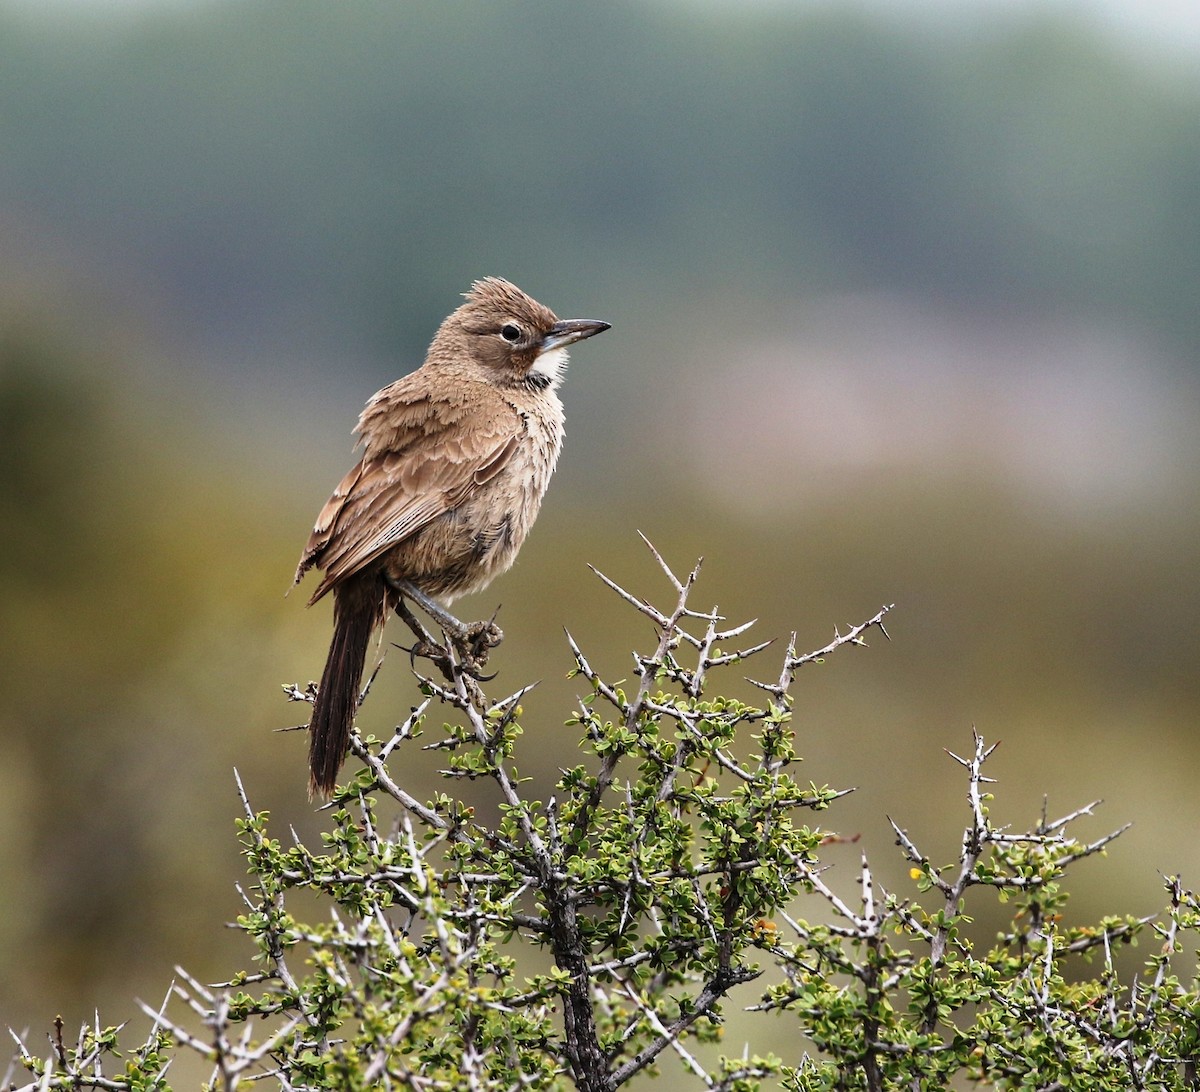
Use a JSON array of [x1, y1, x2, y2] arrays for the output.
[[308, 574, 388, 799]]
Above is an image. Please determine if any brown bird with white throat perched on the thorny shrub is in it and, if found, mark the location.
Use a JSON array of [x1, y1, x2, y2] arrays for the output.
[[295, 277, 608, 797]]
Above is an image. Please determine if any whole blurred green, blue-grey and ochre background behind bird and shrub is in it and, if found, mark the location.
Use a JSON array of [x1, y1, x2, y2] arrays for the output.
[[0, 0, 1200, 1075]]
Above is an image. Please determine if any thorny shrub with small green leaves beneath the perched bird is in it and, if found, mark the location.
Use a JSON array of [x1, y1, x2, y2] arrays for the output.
[[8, 547, 1200, 1092]]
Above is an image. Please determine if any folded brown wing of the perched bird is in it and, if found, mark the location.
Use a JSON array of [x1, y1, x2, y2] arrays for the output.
[[296, 398, 521, 602]]
